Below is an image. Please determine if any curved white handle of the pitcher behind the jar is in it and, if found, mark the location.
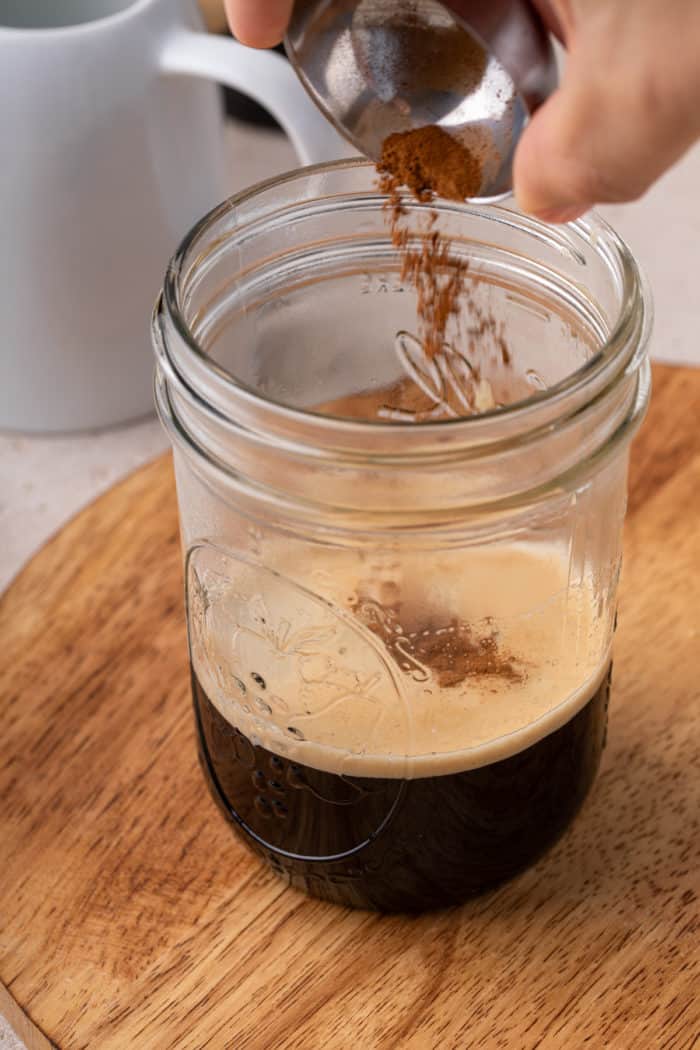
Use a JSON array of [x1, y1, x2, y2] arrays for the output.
[[161, 29, 348, 164]]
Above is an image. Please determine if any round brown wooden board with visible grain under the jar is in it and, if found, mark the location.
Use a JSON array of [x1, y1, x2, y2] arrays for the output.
[[0, 369, 700, 1050]]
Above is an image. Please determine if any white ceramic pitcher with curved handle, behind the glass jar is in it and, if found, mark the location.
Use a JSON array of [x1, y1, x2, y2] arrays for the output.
[[0, 0, 343, 432]]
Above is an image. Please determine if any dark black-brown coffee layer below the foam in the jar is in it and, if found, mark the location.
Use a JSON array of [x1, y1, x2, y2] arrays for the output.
[[192, 674, 610, 911]]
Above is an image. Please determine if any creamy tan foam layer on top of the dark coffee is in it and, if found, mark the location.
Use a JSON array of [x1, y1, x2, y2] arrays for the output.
[[191, 544, 611, 778]]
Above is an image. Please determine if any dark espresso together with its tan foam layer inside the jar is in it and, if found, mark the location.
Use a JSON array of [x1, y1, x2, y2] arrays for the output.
[[187, 545, 610, 911]]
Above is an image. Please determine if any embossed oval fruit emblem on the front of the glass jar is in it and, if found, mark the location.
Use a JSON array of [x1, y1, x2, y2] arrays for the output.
[[187, 546, 411, 860]]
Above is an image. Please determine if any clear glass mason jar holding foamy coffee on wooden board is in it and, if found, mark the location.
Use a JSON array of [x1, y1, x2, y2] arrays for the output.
[[153, 162, 651, 910]]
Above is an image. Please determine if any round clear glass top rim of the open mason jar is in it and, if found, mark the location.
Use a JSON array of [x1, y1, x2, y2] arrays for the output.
[[156, 158, 653, 440]]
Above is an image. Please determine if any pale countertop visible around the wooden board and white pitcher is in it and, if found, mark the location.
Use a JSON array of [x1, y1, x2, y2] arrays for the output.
[[0, 117, 700, 1050]]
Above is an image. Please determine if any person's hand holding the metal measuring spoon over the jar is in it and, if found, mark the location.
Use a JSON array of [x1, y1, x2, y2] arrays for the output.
[[226, 0, 700, 223]]
